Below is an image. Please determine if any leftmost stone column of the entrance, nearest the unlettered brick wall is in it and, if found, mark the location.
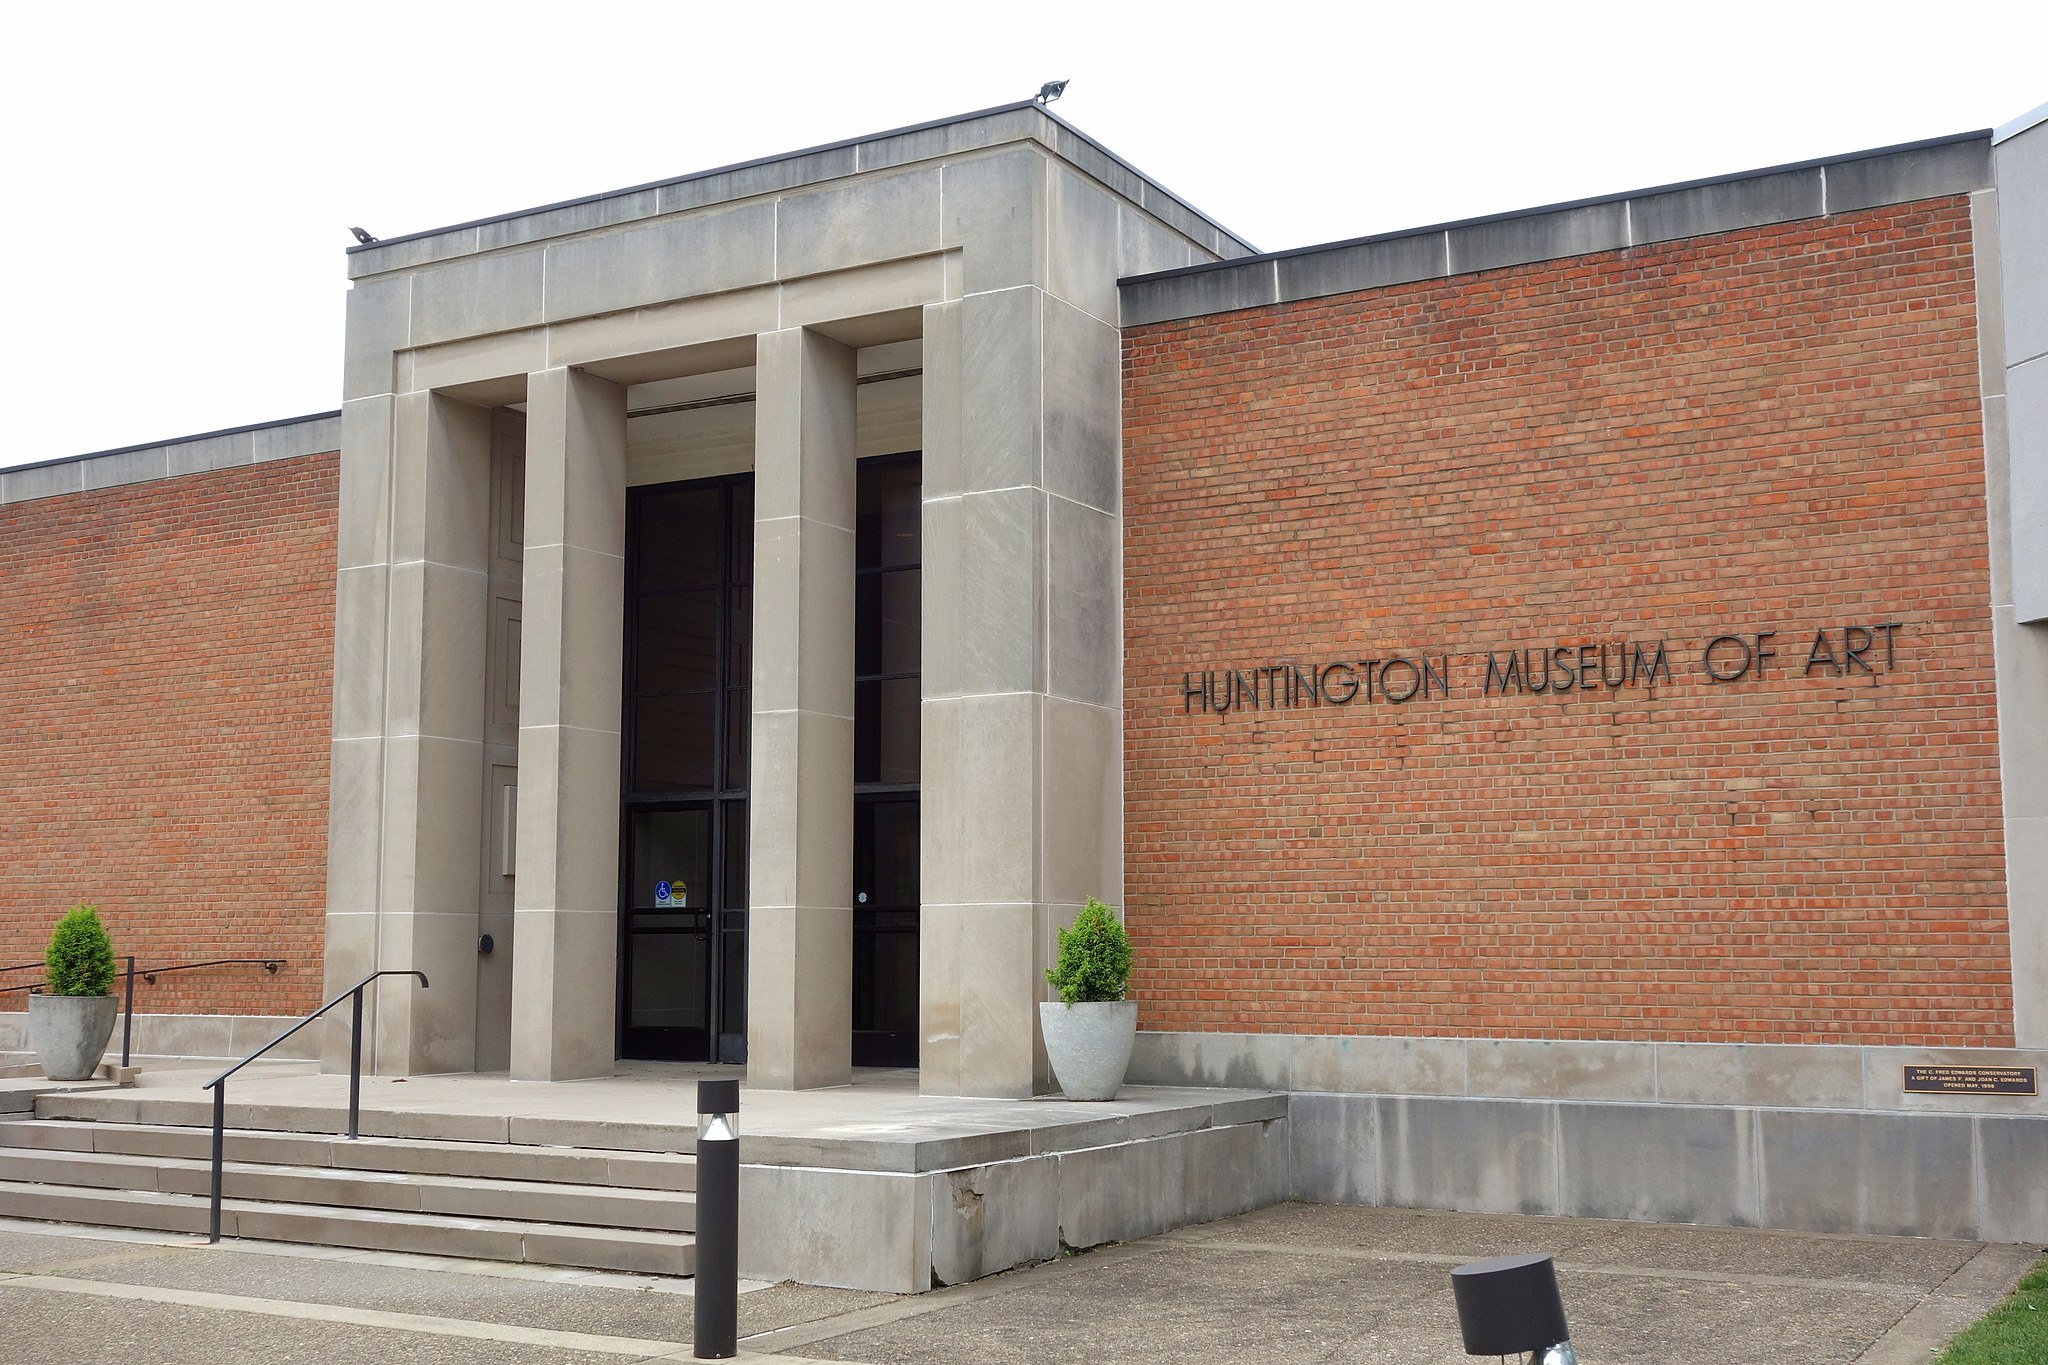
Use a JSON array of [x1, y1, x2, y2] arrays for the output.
[[326, 384, 492, 1074]]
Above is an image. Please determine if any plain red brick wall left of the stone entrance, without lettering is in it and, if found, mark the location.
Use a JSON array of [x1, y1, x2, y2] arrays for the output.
[[0, 454, 336, 1013]]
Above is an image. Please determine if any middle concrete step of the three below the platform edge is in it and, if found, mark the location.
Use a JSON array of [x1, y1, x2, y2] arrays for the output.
[[0, 1148, 696, 1232]]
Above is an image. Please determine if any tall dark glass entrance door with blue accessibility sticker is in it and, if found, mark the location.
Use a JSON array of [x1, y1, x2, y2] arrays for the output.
[[618, 475, 754, 1062]]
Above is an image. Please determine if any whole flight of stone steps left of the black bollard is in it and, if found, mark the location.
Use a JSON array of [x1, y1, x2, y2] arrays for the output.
[[0, 1095, 696, 1275]]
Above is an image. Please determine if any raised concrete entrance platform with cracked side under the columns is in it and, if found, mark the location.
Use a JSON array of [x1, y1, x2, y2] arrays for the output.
[[16, 1062, 1288, 1293]]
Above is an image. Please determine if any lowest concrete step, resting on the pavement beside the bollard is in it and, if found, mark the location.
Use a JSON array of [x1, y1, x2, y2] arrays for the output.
[[0, 1181, 696, 1275]]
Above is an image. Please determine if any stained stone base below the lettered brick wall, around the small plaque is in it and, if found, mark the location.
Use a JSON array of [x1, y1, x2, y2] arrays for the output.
[[1130, 1033, 2048, 1242]]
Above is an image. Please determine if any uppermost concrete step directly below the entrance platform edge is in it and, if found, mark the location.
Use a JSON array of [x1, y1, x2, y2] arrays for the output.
[[0, 1119, 696, 1193]]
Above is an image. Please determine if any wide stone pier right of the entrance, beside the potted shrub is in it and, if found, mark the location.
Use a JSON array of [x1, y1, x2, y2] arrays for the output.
[[920, 284, 1122, 1097]]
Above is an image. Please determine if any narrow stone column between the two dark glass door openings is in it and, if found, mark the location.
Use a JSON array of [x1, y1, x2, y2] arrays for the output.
[[748, 327, 854, 1089]]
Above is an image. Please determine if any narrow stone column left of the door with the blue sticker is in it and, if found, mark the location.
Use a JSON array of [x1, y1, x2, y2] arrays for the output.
[[512, 368, 627, 1081]]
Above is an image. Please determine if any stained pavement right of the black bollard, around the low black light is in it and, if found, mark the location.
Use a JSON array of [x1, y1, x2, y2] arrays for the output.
[[762, 1203, 2040, 1365]]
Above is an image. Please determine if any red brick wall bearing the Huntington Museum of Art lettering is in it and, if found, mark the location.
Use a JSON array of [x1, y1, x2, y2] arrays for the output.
[[1124, 199, 2011, 1044]]
